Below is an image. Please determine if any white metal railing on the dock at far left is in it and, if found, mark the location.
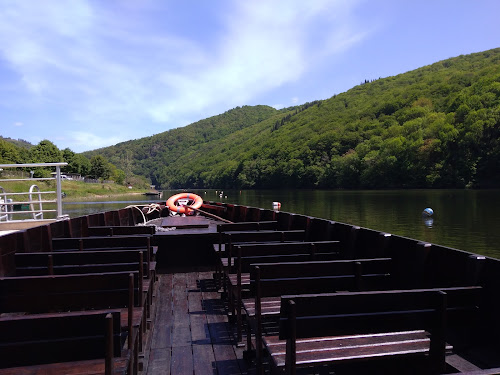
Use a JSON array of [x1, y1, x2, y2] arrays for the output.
[[0, 163, 68, 221]]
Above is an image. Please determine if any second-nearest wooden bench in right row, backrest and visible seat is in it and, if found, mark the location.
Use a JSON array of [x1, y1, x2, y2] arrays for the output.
[[241, 258, 393, 351]]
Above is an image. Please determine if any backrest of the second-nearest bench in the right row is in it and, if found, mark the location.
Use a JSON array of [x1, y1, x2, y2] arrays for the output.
[[250, 258, 392, 297]]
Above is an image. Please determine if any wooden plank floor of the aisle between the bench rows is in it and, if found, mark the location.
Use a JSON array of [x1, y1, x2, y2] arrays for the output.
[[142, 272, 255, 375]]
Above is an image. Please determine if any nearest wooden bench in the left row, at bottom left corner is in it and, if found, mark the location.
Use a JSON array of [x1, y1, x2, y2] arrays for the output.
[[0, 310, 129, 375]]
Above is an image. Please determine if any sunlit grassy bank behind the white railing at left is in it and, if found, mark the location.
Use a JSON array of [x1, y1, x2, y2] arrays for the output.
[[1, 180, 146, 201]]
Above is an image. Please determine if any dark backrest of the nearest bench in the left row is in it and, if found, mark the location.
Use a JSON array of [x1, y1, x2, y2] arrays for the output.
[[0, 310, 123, 368]]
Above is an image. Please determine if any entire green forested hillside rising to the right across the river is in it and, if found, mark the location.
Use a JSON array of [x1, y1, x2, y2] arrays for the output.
[[86, 48, 500, 188]]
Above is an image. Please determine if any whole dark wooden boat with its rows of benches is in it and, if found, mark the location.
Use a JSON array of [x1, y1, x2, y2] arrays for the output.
[[0, 195, 500, 375]]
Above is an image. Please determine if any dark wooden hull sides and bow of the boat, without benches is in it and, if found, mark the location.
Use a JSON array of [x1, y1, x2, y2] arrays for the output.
[[0, 202, 500, 374]]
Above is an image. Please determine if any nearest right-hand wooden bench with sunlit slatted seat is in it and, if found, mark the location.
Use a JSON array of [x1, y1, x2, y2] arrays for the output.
[[264, 287, 481, 374]]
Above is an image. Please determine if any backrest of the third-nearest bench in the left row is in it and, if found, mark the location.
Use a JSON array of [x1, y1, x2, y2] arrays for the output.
[[15, 249, 148, 276]]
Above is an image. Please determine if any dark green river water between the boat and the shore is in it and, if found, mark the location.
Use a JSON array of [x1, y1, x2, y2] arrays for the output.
[[63, 190, 500, 258]]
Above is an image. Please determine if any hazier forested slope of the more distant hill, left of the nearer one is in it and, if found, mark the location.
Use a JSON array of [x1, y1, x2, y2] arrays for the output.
[[83, 106, 281, 187]]
